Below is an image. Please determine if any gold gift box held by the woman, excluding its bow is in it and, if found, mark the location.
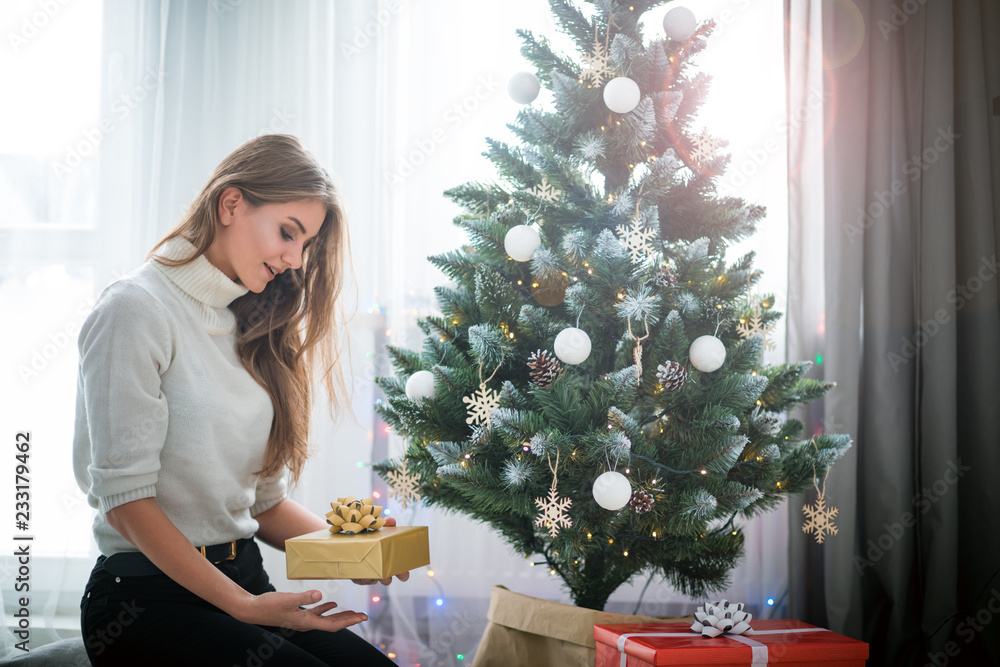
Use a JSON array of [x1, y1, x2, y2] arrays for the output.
[[285, 526, 431, 579]]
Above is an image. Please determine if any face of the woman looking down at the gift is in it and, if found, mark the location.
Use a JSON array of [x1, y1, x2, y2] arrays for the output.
[[205, 188, 326, 293]]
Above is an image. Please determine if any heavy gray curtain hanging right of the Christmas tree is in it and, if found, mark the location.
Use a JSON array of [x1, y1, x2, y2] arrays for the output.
[[785, 0, 1000, 666]]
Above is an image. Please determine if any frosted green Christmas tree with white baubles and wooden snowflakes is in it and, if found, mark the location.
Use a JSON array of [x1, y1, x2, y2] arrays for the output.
[[375, 0, 851, 609]]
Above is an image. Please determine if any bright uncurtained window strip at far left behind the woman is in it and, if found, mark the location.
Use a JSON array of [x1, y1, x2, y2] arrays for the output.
[[0, 0, 102, 646]]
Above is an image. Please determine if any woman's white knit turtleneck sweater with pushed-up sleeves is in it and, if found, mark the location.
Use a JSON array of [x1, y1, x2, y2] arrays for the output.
[[73, 237, 286, 555]]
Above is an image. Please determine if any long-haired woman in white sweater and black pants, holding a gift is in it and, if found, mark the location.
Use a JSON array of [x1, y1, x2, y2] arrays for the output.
[[73, 135, 407, 667]]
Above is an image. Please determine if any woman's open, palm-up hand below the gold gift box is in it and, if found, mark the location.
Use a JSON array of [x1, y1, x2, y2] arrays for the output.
[[233, 590, 368, 632]]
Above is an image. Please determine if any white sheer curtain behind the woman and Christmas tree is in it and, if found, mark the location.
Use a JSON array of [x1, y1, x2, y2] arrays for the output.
[[0, 0, 787, 664]]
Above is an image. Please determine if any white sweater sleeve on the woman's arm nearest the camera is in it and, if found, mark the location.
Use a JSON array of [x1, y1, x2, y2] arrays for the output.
[[74, 281, 172, 513]]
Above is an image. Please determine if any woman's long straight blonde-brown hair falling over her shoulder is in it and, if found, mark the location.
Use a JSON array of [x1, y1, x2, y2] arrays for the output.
[[149, 134, 350, 484]]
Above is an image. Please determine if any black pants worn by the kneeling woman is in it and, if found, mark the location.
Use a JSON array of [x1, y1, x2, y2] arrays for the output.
[[80, 540, 394, 667]]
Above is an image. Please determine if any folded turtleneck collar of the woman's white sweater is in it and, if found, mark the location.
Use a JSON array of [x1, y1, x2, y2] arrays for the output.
[[150, 236, 250, 336]]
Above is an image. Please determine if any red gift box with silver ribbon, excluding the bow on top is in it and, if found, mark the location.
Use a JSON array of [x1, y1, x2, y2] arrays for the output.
[[594, 620, 868, 667]]
